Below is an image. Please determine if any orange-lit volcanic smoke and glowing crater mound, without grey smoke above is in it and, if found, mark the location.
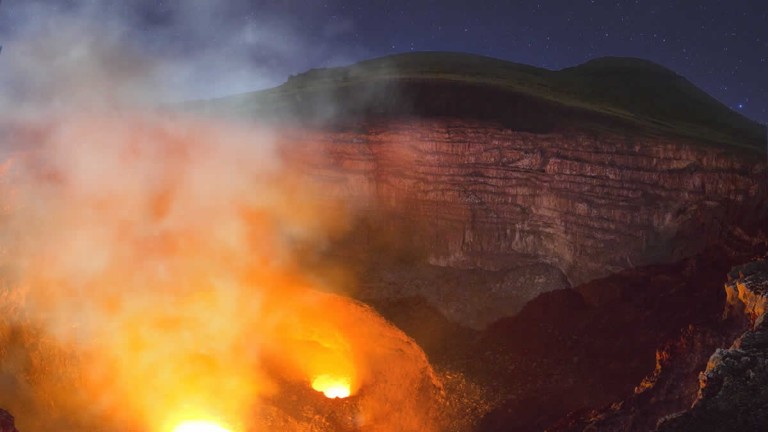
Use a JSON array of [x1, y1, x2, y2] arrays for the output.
[[0, 111, 440, 432]]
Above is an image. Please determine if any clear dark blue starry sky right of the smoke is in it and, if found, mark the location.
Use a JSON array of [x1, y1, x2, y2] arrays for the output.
[[260, 0, 768, 122]]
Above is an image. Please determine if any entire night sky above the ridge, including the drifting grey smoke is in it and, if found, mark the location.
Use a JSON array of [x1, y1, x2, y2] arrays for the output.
[[0, 0, 768, 122]]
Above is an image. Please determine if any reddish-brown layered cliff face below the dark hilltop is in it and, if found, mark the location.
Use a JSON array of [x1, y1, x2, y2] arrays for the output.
[[287, 118, 768, 325]]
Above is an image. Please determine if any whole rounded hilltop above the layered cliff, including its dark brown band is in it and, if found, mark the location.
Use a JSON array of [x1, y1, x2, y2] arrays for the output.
[[193, 52, 766, 153]]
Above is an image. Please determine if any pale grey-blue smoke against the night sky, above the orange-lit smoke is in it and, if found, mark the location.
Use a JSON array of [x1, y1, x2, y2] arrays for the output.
[[0, 0, 365, 102]]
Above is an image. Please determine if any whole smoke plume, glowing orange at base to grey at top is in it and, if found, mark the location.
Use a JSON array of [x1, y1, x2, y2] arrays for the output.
[[0, 0, 439, 432]]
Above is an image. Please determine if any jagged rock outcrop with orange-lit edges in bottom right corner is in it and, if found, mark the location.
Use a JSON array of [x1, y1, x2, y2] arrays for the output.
[[549, 255, 768, 432]]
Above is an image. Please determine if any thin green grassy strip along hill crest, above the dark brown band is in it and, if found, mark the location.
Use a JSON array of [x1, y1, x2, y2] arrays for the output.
[[196, 52, 766, 153]]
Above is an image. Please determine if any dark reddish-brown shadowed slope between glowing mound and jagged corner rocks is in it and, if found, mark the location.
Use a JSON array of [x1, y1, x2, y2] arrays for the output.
[[475, 249, 739, 432]]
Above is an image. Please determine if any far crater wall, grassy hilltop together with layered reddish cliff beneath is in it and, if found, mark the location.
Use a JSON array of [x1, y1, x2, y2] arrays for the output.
[[196, 53, 768, 328]]
